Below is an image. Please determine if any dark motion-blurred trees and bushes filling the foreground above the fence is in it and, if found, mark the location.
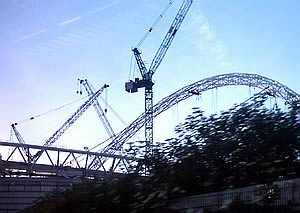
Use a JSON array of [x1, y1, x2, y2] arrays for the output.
[[23, 95, 300, 213]]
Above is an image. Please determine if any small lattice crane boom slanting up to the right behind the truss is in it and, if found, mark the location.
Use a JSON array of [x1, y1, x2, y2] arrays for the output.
[[33, 84, 109, 162]]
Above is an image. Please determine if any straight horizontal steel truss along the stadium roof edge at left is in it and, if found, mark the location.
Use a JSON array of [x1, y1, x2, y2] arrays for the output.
[[0, 141, 137, 177]]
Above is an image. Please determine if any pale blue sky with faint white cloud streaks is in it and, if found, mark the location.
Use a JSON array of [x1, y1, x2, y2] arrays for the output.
[[0, 0, 300, 153]]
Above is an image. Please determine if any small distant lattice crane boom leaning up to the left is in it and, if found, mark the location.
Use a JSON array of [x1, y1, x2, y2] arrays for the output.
[[78, 79, 116, 140]]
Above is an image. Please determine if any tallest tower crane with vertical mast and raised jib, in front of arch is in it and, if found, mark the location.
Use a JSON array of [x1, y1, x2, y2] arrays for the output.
[[125, 0, 193, 153]]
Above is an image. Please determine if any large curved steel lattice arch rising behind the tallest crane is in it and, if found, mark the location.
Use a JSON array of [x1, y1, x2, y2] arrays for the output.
[[102, 73, 300, 154]]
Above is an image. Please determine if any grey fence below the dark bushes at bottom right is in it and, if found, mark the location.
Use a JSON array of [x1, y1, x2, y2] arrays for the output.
[[172, 178, 300, 212]]
